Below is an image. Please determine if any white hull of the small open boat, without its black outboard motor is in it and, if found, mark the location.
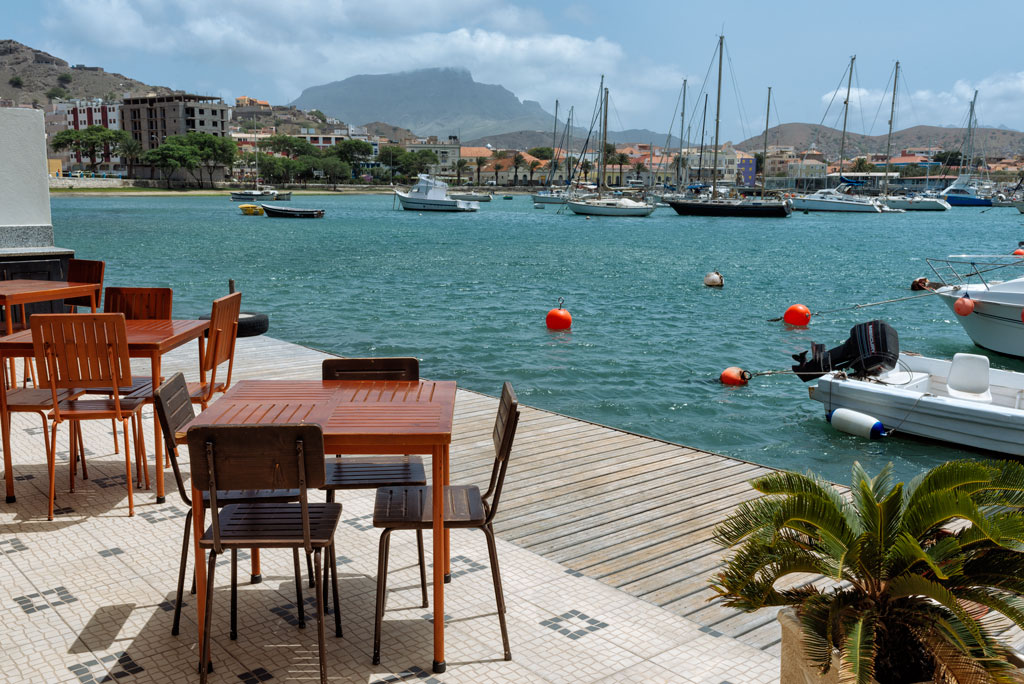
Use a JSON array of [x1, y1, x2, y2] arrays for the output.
[[808, 353, 1024, 456]]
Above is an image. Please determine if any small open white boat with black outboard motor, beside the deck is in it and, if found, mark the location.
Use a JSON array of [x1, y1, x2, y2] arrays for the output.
[[794, 320, 1024, 456]]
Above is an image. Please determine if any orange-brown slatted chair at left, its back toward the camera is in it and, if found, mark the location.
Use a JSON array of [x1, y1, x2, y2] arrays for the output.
[[32, 313, 150, 520]]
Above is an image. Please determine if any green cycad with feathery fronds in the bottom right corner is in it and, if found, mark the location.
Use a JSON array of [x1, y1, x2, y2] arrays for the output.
[[712, 461, 1024, 684]]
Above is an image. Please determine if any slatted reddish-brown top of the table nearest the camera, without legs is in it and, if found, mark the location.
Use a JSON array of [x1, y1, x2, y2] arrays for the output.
[[175, 380, 456, 454]]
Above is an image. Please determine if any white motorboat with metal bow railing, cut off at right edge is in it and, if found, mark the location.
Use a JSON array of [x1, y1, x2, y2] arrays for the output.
[[926, 254, 1024, 357]]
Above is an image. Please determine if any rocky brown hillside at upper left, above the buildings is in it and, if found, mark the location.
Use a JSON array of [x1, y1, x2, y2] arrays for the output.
[[0, 40, 172, 104]]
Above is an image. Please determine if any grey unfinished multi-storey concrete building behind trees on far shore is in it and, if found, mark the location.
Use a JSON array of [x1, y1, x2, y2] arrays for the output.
[[121, 93, 230, 149]]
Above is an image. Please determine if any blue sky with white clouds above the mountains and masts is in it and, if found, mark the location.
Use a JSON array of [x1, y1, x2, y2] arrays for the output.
[[8, 0, 1024, 141]]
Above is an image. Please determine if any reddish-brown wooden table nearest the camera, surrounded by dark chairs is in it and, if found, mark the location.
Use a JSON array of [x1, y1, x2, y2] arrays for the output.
[[175, 380, 456, 672]]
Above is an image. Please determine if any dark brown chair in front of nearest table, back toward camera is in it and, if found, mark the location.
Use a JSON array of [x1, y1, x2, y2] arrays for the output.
[[188, 425, 341, 684]]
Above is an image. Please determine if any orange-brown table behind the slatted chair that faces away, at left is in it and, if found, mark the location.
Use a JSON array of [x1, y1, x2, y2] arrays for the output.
[[0, 319, 210, 504]]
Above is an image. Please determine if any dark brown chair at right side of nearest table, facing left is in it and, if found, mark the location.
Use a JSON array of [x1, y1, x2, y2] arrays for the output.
[[373, 383, 519, 665]]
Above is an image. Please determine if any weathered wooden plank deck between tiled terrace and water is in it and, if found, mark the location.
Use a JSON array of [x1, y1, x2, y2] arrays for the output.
[[153, 337, 1024, 654]]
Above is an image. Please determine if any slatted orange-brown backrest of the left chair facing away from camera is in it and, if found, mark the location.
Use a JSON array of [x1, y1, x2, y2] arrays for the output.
[[31, 313, 131, 393]]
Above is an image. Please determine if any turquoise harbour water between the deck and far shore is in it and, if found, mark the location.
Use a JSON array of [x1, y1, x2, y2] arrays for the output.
[[52, 196, 1024, 481]]
